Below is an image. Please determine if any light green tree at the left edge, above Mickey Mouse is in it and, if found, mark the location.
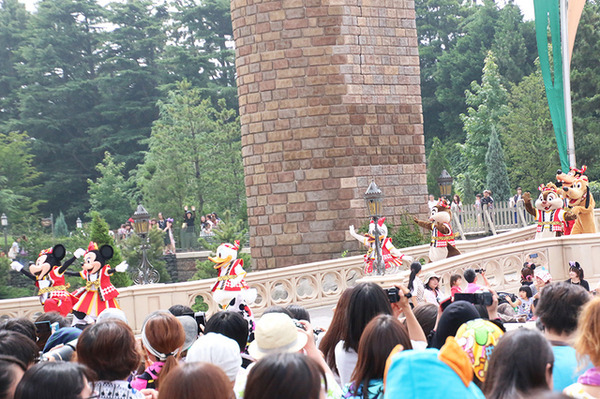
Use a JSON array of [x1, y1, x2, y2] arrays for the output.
[[0, 132, 43, 225]]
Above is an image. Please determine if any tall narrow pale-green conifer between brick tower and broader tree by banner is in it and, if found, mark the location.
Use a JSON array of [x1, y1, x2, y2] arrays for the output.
[[460, 51, 508, 191]]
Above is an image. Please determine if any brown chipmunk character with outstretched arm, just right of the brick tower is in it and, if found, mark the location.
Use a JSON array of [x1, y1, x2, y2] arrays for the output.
[[413, 198, 460, 262]]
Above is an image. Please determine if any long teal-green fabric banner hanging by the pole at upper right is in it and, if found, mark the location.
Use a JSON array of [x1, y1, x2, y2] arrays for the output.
[[533, 0, 569, 171]]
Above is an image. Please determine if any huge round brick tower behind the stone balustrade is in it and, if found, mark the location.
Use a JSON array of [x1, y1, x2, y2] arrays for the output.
[[231, 0, 427, 269]]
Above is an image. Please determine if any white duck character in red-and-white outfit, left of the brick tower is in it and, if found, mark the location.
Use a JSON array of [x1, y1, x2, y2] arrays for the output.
[[208, 240, 257, 309]]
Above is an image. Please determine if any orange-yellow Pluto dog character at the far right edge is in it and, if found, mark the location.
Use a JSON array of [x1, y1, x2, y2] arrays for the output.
[[556, 165, 596, 234]]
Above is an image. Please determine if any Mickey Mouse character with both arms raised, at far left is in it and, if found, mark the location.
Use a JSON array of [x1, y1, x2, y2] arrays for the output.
[[10, 244, 85, 317]]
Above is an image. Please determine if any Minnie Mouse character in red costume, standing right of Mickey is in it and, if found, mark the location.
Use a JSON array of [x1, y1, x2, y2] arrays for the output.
[[73, 242, 128, 325]]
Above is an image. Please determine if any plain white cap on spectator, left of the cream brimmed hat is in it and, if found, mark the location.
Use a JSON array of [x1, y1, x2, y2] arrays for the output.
[[185, 333, 242, 382]]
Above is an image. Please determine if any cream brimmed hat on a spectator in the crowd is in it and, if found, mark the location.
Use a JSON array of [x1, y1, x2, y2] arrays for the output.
[[248, 313, 308, 359]]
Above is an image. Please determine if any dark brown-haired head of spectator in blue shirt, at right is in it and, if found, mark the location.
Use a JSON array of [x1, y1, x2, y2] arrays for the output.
[[535, 282, 590, 335]]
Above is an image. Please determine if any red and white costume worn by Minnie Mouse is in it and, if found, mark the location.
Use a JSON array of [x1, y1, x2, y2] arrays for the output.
[[73, 265, 120, 317]]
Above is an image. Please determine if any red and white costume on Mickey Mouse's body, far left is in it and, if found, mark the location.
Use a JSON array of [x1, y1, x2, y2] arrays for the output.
[[35, 266, 73, 316]]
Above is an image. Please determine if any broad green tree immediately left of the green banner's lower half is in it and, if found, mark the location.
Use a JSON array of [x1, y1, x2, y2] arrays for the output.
[[500, 62, 560, 193]]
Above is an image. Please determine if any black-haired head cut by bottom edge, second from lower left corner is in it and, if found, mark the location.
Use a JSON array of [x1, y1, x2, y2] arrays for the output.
[[15, 362, 92, 399]]
